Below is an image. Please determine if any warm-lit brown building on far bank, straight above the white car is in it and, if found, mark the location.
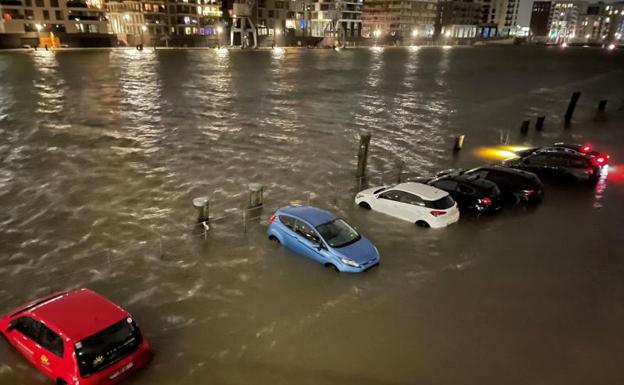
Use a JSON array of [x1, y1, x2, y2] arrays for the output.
[[362, 0, 437, 40]]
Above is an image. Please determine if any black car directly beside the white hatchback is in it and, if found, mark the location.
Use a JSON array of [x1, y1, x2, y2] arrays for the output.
[[424, 173, 503, 213]]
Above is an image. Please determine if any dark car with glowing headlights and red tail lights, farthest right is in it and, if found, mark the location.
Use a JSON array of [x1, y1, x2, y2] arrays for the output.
[[503, 145, 608, 182]]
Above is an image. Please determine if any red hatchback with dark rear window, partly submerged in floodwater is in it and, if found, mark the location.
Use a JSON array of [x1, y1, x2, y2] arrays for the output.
[[0, 289, 152, 385]]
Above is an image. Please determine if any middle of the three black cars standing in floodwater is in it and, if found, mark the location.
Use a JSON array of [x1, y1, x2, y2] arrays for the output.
[[462, 165, 544, 204]]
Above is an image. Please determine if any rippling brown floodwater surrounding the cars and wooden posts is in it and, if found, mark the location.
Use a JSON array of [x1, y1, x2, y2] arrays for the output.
[[0, 47, 624, 385]]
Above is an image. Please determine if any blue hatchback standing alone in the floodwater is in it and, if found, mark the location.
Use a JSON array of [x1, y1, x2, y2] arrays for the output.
[[268, 206, 379, 273]]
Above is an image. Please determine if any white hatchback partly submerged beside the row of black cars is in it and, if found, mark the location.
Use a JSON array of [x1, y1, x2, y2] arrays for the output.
[[355, 182, 459, 228]]
